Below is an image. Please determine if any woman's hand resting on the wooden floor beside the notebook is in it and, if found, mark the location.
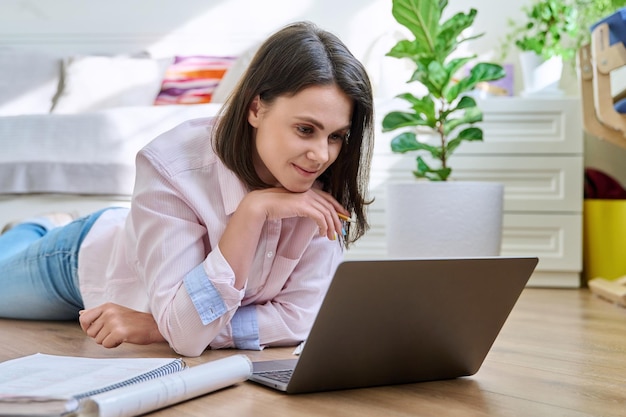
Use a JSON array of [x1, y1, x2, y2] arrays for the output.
[[79, 303, 165, 348]]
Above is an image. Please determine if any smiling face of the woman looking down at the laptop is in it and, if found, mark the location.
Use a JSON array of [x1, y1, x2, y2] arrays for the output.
[[248, 85, 352, 192]]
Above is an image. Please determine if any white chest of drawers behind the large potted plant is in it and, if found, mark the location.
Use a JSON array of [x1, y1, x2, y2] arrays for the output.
[[347, 97, 584, 287]]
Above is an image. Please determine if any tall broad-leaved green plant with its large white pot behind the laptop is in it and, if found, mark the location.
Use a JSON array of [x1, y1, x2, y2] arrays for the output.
[[382, 0, 505, 257]]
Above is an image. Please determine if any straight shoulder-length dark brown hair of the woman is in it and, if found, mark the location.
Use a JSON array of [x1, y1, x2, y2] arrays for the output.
[[214, 22, 374, 247]]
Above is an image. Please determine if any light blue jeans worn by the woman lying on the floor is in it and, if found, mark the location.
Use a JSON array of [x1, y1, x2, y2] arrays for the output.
[[0, 209, 106, 320]]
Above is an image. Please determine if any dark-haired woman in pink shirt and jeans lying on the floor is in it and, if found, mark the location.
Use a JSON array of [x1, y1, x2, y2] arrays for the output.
[[0, 22, 373, 356]]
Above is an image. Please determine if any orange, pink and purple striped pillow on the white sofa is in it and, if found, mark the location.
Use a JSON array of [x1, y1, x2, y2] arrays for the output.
[[154, 55, 236, 105]]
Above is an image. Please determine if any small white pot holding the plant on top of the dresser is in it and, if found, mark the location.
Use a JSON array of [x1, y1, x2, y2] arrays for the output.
[[519, 51, 564, 97]]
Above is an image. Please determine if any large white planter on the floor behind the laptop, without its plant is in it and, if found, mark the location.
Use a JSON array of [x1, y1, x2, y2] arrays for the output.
[[386, 181, 504, 258]]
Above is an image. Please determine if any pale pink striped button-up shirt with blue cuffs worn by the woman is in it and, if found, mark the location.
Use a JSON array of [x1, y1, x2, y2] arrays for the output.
[[78, 118, 343, 356]]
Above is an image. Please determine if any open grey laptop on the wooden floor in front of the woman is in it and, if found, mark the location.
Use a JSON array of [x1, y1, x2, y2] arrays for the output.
[[250, 257, 538, 394]]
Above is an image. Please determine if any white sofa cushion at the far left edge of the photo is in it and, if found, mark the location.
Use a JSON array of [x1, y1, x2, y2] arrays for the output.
[[0, 49, 61, 116]]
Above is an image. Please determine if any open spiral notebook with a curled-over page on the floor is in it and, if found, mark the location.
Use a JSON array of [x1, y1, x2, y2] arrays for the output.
[[0, 354, 252, 417]]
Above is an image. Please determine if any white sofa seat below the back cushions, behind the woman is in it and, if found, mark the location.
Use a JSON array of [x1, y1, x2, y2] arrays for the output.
[[0, 104, 220, 196]]
